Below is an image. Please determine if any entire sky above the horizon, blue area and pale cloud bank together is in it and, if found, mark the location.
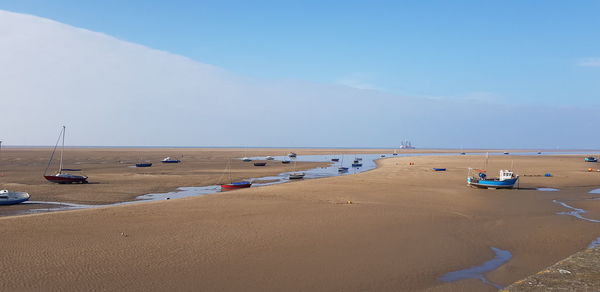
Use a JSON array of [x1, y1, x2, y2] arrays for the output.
[[0, 0, 600, 149]]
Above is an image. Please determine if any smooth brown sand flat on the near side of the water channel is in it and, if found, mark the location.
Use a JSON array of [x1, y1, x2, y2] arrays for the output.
[[0, 150, 600, 291]]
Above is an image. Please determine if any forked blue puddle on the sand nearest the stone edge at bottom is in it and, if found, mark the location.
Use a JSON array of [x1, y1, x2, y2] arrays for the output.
[[438, 247, 512, 289]]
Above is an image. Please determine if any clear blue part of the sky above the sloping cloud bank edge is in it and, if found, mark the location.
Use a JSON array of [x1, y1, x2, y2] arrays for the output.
[[0, 0, 600, 107]]
